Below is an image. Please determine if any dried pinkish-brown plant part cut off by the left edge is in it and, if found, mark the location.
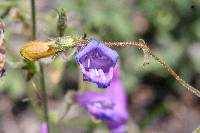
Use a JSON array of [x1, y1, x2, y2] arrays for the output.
[[0, 22, 6, 77]]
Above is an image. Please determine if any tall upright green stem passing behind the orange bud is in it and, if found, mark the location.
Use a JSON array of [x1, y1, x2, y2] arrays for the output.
[[31, 0, 50, 133]]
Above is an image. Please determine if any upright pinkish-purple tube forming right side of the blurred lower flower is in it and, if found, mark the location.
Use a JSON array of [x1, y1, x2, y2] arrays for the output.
[[106, 66, 128, 133]]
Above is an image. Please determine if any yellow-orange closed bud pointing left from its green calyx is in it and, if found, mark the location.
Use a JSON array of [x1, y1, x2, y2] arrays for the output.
[[20, 41, 56, 61]]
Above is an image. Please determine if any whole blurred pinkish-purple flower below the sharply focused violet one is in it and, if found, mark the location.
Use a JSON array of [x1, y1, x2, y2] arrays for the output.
[[76, 68, 128, 133]]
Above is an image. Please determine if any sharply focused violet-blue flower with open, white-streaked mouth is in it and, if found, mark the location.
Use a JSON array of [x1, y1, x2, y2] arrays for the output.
[[76, 39, 118, 88]]
